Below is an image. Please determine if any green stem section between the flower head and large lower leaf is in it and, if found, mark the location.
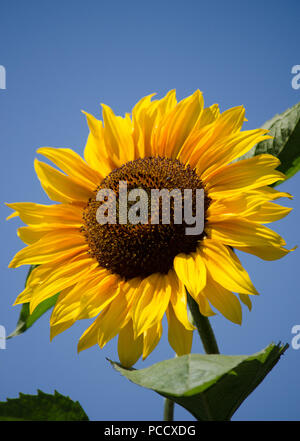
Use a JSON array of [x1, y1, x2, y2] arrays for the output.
[[187, 292, 220, 354]]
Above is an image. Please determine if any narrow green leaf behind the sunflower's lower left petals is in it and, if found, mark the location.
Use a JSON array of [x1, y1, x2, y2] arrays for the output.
[[7, 265, 59, 338]]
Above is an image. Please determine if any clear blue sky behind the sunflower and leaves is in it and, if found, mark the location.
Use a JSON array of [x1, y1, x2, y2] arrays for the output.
[[0, 0, 300, 420]]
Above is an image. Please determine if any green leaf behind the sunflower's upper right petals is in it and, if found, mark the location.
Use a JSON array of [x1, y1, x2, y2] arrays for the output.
[[240, 103, 300, 185]]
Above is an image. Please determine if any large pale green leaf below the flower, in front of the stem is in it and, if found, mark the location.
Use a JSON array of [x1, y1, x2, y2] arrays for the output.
[[109, 344, 288, 421]]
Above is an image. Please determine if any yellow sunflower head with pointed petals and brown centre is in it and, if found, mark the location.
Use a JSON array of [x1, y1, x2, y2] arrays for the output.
[[7, 90, 291, 366]]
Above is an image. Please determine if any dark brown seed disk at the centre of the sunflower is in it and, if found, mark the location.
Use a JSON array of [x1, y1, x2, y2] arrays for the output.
[[82, 157, 210, 280]]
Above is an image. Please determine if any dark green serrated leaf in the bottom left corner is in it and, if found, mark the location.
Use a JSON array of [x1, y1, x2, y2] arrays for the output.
[[0, 390, 88, 421]]
